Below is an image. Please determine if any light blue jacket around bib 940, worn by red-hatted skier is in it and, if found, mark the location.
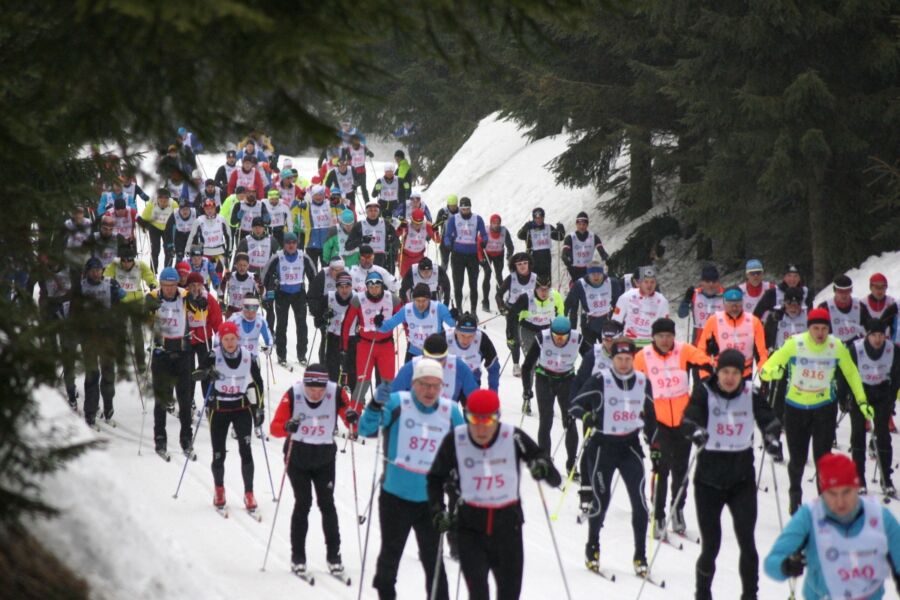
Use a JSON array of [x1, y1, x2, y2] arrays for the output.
[[763, 496, 900, 600]]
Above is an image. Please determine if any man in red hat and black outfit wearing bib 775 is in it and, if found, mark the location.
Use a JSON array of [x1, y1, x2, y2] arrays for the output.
[[428, 390, 562, 598]]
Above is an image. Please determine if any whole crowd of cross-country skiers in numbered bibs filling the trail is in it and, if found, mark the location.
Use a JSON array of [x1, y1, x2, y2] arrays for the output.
[[27, 124, 900, 600]]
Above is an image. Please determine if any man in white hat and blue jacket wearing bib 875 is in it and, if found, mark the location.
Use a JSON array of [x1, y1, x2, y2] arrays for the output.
[[359, 358, 465, 600]]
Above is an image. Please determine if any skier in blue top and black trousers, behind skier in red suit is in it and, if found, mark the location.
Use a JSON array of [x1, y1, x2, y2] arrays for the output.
[[262, 232, 316, 368]]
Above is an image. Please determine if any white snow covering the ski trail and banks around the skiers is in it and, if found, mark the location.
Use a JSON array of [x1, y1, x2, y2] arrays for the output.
[[26, 118, 900, 600]]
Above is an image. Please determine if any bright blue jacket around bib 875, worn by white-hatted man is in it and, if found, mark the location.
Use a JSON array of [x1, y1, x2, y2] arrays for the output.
[[359, 390, 471, 502]]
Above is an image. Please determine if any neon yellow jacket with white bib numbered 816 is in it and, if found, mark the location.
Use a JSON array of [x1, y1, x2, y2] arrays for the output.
[[759, 331, 866, 409]]
